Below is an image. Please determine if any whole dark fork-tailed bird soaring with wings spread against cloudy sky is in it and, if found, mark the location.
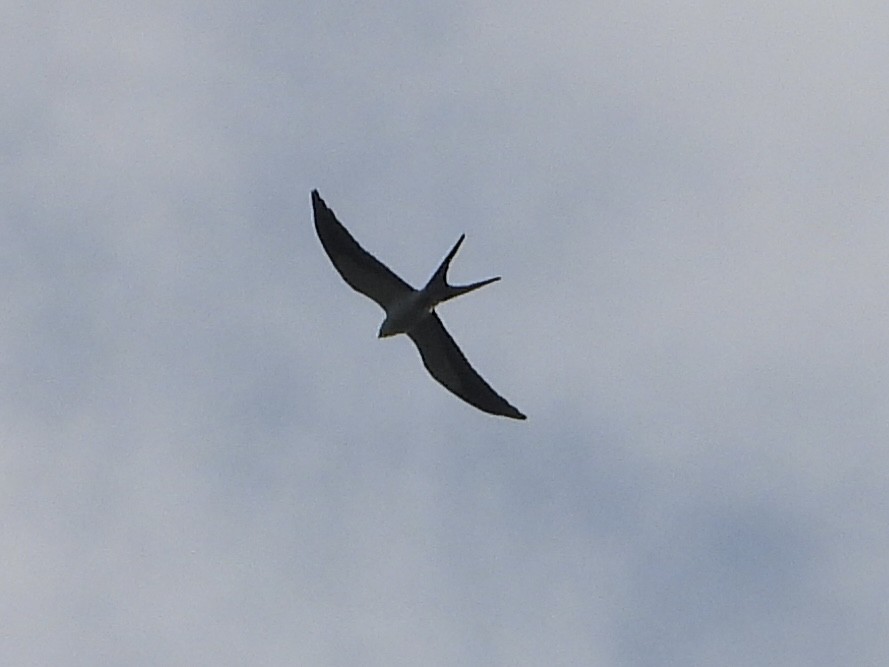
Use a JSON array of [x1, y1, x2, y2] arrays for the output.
[[312, 190, 525, 419]]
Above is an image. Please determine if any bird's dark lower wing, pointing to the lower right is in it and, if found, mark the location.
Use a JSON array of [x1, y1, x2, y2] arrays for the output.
[[408, 313, 525, 419]]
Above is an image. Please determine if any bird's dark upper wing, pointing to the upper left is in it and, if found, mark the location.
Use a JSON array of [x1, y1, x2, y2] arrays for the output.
[[312, 190, 413, 308]]
